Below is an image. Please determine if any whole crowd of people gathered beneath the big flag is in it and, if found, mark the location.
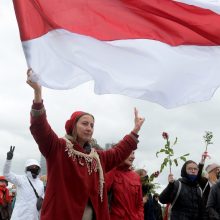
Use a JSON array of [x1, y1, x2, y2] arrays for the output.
[[0, 70, 220, 220]]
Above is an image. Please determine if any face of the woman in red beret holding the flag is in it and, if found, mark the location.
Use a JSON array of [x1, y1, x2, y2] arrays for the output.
[[73, 115, 94, 146]]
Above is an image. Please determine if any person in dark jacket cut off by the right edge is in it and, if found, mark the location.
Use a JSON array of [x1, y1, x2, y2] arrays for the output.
[[206, 169, 220, 220]]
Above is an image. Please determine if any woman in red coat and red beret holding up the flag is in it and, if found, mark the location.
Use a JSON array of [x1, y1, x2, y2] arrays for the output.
[[27, 70, 144, 220]]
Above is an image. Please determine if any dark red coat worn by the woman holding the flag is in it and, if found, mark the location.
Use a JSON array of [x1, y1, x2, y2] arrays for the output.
[[30, 103, 137, 220]]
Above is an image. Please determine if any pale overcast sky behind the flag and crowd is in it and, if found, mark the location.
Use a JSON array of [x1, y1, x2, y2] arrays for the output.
[[0, 0, 220, 192]]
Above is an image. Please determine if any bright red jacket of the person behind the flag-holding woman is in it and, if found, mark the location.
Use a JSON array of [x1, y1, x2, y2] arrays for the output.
[[105, 167, 144, 220]]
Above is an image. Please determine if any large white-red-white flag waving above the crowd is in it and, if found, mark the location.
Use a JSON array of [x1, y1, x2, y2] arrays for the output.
[[13, 0, 220, 108]]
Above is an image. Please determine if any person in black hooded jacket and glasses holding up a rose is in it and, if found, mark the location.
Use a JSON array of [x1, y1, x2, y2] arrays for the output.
[[159, 160, 204, 220]]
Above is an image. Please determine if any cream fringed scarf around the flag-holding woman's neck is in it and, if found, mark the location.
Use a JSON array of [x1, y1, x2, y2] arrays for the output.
[[63, 137, 105, 201]]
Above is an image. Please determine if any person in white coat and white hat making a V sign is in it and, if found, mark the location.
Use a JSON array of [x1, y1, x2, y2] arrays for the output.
[[3, 146, 44, 220]]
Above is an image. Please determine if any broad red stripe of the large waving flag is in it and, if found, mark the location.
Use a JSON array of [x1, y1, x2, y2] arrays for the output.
[[14, 0, 220, 46]]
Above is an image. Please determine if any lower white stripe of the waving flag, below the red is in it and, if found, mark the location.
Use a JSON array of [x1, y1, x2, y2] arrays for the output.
[[23, 29, 220, 108]]
